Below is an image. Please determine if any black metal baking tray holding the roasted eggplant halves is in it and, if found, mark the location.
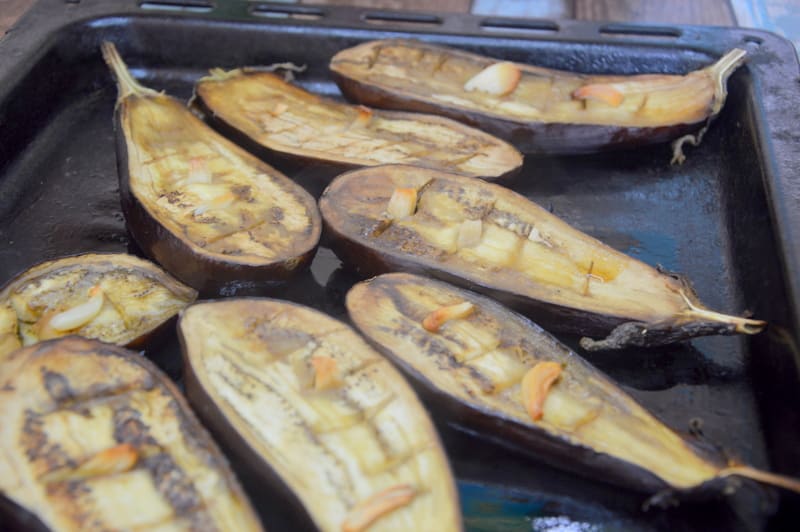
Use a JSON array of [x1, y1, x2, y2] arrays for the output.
[[0, 0, 800, 530]]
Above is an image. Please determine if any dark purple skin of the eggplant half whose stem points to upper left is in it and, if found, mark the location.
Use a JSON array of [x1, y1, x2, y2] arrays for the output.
[[114, 111, 322, 296]]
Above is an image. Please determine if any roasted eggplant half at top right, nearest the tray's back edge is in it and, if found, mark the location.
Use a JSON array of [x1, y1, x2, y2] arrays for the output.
[[330, 39, 745, 161]]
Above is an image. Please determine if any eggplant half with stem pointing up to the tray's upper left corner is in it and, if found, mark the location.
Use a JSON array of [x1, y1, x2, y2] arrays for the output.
[[103, 43, 321, 293]]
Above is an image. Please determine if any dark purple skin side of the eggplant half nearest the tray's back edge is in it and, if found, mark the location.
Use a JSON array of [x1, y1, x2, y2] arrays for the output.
[[332, 71, 692, 155]]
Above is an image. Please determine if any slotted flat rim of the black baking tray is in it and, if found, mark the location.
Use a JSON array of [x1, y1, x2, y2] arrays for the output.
[[0, 0, 800, 524]]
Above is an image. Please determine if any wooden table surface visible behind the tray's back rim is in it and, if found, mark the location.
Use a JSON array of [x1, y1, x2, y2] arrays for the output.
[[0, 0, 736, 35]]
